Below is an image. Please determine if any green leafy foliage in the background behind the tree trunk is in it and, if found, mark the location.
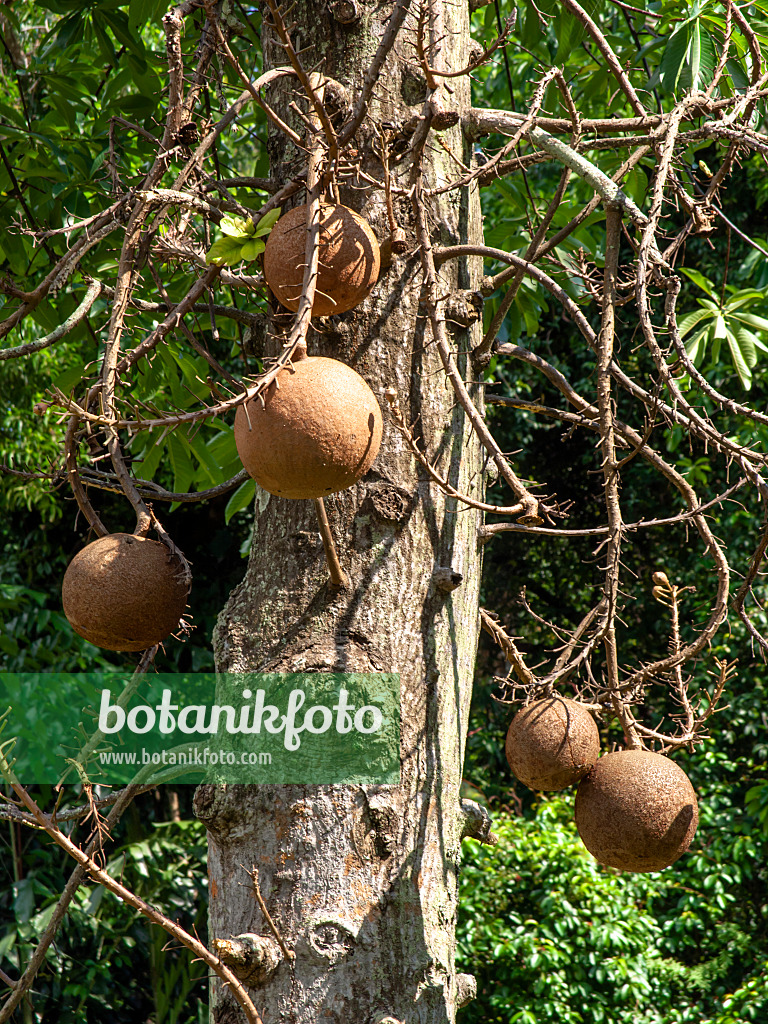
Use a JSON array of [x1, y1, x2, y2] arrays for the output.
[[0, 0, 768, 1024]]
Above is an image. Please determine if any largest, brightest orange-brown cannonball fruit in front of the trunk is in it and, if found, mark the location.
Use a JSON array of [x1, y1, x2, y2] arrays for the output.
[[234, 355, 382, 498]]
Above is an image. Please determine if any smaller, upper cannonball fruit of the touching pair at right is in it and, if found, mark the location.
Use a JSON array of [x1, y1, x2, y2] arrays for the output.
[[506, 695, 600, 793]]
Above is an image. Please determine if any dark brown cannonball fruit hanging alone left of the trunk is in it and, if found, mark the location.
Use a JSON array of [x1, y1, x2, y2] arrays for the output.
[[61, 534, 187, 650]]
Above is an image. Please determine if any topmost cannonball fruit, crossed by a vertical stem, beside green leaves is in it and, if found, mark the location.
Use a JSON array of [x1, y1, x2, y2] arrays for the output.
[[264, 203, 380, 316]]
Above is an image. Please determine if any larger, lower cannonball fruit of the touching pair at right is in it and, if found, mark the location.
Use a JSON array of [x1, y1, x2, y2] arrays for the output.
[[575, 751, 698, 871]]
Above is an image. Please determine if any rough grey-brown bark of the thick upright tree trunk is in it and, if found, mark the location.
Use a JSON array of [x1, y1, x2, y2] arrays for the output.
[[196, 0, 482, 1024]]
